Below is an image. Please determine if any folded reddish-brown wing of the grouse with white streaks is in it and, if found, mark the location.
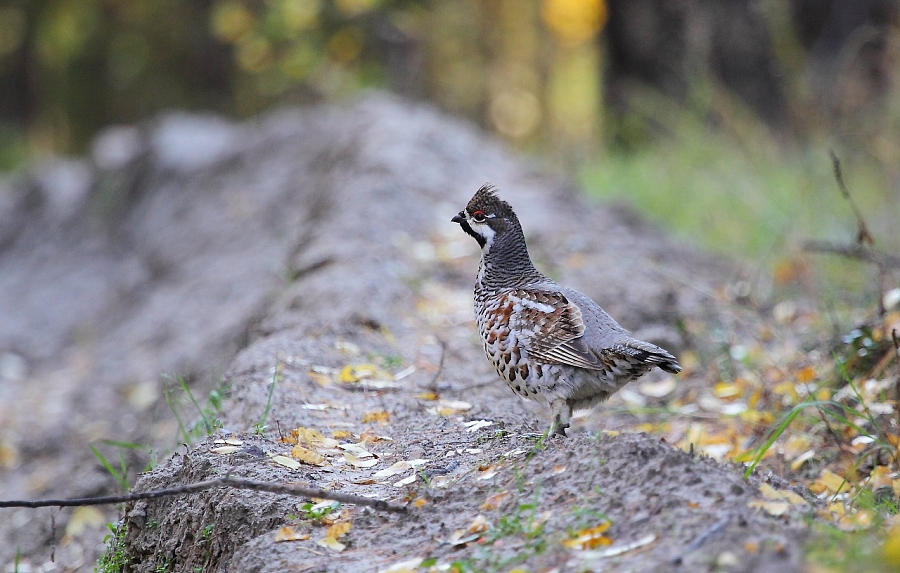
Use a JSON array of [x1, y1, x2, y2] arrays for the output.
[[507, 287, 604, 370]]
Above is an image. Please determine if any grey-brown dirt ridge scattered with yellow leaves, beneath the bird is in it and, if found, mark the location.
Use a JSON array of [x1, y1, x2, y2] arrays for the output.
[[0, 95, 805, 572]]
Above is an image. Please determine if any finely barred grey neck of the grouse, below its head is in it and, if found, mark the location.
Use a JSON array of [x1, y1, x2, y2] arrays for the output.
[[476, 228, 544, 291]]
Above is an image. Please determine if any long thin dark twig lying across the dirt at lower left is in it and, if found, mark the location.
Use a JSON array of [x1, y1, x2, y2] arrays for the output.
[[0, 476, 406, 513]]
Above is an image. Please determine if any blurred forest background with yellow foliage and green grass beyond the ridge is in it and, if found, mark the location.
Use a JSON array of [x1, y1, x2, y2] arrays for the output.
[[0, 0, 900, 283]]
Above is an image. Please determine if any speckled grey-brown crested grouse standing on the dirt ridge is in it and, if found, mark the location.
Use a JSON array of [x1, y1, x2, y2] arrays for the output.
[[451, 184, 681, 437]]
